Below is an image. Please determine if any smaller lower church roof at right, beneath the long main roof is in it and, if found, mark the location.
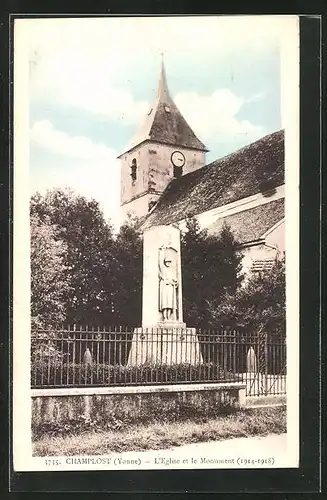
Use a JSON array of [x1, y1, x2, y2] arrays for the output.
[[207, 198, 285, 244]]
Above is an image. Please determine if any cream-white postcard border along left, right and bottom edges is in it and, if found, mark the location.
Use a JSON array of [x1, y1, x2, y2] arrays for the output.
[[12, 16, 299, 471]]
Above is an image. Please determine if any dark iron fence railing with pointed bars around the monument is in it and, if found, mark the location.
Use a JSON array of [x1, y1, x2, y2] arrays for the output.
[[31, 327, 286, 396]]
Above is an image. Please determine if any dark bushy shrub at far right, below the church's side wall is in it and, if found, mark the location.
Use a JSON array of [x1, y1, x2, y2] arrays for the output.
[[209, 258, 286, 335]]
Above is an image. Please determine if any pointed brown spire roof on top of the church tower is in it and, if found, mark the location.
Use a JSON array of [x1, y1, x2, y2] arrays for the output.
[[120, 62, 208, 156]]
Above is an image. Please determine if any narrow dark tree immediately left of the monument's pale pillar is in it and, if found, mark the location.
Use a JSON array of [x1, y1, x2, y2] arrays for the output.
[[114, 218, 143, 325]]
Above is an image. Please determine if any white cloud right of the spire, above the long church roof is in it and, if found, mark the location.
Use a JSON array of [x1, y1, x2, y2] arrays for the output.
[[175, 89, 265, 154]]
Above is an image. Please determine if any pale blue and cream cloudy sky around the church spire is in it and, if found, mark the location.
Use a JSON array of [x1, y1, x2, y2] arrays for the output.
[[21, 16, 288, 230]]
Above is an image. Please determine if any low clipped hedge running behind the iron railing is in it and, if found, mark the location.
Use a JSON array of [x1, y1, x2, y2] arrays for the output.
[[31, 359, 238, 387]]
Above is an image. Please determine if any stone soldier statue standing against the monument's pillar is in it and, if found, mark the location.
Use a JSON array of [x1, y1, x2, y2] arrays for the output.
[[159, 246, 178, 321]]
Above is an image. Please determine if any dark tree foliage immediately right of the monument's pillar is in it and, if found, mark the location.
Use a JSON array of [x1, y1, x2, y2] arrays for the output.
[[182, 218, 243, 327]]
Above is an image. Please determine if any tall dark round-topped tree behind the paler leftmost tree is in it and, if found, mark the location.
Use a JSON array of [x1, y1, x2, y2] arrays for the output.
[[31, 189, 115, 325]]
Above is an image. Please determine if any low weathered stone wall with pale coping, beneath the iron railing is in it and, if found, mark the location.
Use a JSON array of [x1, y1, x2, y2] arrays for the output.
[[31, 383, 246, 426]]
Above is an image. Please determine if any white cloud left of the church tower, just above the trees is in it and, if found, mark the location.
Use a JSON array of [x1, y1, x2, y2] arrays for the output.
[[30, 120, 120, 227]]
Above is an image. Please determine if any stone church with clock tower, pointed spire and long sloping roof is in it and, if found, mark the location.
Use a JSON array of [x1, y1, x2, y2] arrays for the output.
[[119, 62, 285, 274]]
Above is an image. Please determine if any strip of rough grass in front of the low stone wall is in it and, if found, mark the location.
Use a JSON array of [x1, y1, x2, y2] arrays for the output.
[[33, 407, 286, 456]]
